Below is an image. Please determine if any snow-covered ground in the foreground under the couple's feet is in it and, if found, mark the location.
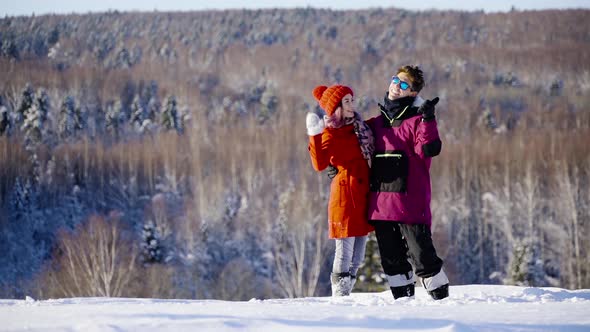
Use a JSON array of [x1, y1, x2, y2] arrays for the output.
[[0, 285, 590, 332]]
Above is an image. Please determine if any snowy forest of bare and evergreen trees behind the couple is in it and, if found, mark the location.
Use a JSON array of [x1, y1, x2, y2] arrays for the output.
[[0, 8, 590, 300]]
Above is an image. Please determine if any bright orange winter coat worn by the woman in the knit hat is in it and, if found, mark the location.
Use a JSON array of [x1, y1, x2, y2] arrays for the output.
[[309, 124, 373, 239]]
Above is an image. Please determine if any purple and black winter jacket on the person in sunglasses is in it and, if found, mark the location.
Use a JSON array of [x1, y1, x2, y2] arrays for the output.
[[367, 97, 442, 226]]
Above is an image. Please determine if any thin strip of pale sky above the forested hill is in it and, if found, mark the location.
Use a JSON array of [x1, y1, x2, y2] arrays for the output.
[[0, 0, 590, 17]]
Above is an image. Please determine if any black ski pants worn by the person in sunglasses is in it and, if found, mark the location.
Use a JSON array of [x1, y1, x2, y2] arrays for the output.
[[371, 220, 443, 278]]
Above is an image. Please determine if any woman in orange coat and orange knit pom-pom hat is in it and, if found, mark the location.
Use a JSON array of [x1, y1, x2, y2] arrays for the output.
[[306, 85, 374, 296]]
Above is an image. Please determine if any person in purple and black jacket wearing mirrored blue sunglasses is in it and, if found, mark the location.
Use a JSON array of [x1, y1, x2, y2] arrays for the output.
[[367, 66, 449, 300]]
